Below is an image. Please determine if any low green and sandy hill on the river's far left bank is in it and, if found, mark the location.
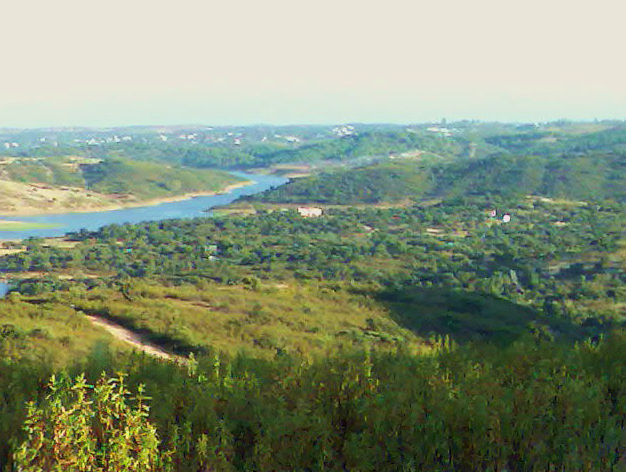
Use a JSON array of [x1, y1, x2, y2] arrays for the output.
[[0, 156, 242, 215]]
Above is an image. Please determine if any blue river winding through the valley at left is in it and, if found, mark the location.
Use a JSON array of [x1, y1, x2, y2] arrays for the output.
[[0, 172, 288, 240]]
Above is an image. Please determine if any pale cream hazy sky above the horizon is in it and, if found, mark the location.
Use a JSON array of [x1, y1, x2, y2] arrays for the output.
[[0, 0, 626, 127]]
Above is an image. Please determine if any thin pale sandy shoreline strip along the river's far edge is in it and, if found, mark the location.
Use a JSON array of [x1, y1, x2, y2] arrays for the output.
[[0, 180, 257, 218]]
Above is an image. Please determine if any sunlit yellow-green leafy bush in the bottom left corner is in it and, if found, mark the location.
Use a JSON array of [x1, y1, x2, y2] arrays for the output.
[[14, 374, 166, 472]]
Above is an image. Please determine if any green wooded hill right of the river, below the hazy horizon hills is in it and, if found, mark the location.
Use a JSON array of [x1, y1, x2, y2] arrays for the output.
[[245, 147, 626, 205]]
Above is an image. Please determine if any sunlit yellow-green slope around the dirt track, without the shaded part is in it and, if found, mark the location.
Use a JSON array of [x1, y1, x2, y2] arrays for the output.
[[0, 281, 428, 364]]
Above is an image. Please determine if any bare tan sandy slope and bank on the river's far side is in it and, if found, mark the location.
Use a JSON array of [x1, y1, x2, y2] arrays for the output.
[[0, 180, 255, 216]]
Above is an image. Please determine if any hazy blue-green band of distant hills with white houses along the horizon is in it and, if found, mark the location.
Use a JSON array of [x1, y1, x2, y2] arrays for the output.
[[0, 120, 626, 168]]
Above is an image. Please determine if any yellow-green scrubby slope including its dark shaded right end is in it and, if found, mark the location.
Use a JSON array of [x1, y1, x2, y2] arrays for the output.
[[0, 268, 578, 365]]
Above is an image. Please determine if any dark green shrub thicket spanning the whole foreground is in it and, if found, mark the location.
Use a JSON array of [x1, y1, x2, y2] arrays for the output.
[[6, 333, 626, 472]]
